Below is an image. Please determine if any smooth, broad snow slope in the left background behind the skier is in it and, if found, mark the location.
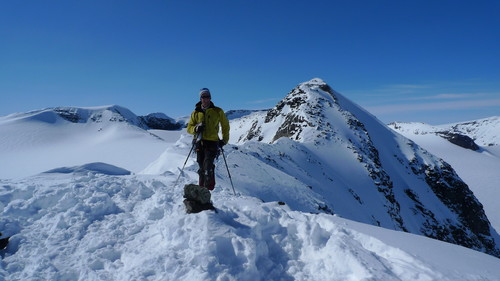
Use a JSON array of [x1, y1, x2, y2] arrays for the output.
[[0, 106, 170, 178]]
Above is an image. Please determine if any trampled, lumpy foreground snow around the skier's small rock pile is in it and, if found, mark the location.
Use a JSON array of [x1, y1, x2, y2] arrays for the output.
[[0, 172, 500, 281]]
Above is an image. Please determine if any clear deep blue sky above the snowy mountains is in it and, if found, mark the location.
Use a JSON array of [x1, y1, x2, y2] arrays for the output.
[[0, 0, 500, 124]]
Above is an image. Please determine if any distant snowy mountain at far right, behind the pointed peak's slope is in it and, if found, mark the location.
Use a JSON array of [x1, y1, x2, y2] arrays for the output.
[[389, 116, 500, 232]]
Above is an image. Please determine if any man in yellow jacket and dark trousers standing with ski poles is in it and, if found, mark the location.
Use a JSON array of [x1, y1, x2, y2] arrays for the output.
[[187, 88, 229, 190]]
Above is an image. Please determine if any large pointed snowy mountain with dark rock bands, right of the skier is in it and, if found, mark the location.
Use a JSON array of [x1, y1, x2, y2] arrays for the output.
[[220, 79, 500, 256]]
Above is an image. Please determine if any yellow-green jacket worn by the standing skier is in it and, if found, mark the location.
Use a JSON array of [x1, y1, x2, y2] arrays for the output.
[[187, 102, 229, 143]]
